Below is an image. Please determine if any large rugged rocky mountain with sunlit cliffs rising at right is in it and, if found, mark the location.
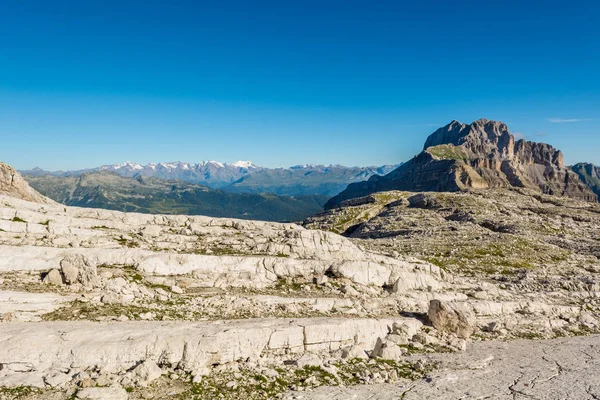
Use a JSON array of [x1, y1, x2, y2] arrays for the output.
[[325, 119, 598, 208]]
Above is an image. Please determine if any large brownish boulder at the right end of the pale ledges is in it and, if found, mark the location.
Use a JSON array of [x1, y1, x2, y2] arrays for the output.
[[427, 300, 475, 339]]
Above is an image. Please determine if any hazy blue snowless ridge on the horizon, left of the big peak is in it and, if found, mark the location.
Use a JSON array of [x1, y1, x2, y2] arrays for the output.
[[223, 165, 397, 196]]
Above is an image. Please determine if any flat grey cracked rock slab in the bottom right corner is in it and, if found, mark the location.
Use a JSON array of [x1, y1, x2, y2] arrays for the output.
[[284, 336, 600, 400]]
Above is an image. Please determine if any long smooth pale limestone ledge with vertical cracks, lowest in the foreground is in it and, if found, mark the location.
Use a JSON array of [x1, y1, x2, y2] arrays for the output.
[[0, 318, 402, 381]]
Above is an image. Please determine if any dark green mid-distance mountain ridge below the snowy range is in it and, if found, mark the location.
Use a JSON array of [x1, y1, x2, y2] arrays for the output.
[[25, 171, 327, 221]]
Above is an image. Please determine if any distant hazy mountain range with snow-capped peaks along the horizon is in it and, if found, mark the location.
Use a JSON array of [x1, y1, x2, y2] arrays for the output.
[[20, 161, 398, 197]]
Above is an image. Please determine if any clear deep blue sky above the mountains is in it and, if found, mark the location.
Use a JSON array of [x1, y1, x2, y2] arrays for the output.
[[0, 0, 600, 169]]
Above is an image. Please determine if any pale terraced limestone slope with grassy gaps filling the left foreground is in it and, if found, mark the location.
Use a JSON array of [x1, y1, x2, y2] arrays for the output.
[[0, 165, 450, 399]]
